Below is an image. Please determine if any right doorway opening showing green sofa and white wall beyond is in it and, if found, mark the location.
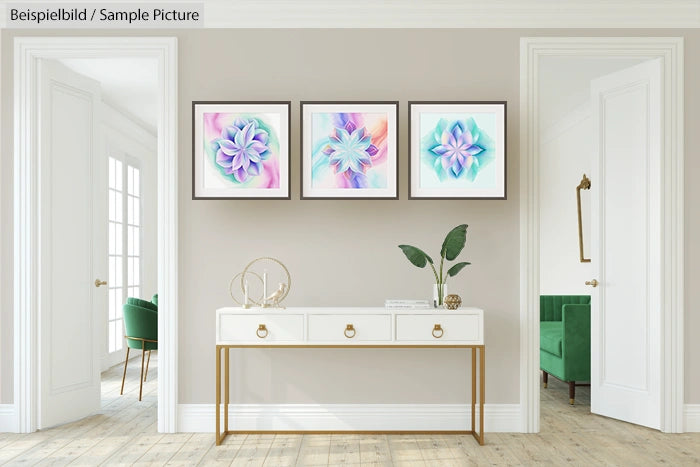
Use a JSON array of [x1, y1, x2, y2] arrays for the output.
[[538, 56, 660, 429]]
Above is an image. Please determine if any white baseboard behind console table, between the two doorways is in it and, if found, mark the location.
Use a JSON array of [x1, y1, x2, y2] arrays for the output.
[[177, 404, 520, 433]]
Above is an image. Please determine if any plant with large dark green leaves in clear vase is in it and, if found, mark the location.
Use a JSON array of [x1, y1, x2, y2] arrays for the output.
[[399, 224, 471, 306]]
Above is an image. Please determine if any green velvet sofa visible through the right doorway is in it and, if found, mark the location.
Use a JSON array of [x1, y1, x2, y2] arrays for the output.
[[540, 295, 591, 404]]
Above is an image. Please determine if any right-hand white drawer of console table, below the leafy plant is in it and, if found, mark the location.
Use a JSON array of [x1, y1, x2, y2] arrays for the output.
[[396, 313, 483, 344]]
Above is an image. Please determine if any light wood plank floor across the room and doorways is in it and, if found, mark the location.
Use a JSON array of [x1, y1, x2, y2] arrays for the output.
[[0, 353, 700, 466]]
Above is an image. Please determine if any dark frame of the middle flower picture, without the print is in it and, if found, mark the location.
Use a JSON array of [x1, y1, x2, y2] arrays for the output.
[[299, 101, 399, 200]]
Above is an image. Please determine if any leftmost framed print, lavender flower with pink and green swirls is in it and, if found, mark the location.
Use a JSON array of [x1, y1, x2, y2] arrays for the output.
[[192, 102, 290, 199]]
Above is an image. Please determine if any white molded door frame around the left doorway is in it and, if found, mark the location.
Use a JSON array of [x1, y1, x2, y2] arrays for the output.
[[13, 37, 178, 433]]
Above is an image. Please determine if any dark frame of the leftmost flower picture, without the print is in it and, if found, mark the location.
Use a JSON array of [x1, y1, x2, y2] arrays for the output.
[[192, 101, 292, 201]]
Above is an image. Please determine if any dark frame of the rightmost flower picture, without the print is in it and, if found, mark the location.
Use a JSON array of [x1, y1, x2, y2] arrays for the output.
[[408, 101, 508, 200]]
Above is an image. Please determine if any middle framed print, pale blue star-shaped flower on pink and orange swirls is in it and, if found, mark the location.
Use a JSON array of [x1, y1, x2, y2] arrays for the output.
[[301, 102, 399, 199]]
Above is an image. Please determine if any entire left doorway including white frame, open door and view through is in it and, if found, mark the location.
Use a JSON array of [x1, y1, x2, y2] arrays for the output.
[[14, 37, 178, 432]]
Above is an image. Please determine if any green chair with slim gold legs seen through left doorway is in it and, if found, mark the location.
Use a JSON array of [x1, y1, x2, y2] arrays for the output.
[[120, 304, 158, 400]]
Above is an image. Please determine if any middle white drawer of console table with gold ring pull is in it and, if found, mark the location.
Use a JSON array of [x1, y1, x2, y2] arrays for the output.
[[309, 314, 391, 344]]
